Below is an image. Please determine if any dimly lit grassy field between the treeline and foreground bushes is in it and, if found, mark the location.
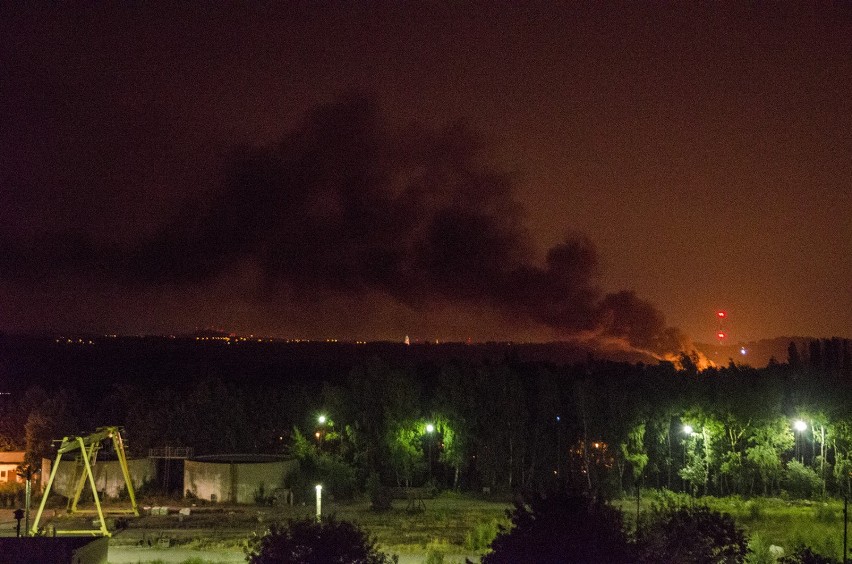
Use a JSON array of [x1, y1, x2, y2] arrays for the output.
[[30, 491, 843, 562]]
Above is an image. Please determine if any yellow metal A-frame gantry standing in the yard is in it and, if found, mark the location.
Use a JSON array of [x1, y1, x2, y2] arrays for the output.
[[29, 427, 139, 537]]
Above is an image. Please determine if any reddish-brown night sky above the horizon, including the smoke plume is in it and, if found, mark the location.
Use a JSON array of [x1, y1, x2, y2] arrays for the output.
[[0, 2, 852, 352]]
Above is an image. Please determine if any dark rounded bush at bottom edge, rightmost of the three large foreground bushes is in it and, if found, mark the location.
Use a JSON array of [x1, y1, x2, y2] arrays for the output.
[[637, 506, 748, 564]]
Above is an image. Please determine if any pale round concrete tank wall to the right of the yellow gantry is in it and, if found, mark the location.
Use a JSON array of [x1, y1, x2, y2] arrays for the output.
[[183, 460, 298, 503]]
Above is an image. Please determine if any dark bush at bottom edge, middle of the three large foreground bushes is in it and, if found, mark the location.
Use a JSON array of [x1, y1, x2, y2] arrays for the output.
[[482, 494, 634, 564]]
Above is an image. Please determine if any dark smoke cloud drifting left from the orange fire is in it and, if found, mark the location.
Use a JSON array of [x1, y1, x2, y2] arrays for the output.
[[0, 97, 684, 353]]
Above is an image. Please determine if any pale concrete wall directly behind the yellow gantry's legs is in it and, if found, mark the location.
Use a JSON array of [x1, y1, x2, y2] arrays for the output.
[[42, 458, 156, 498]]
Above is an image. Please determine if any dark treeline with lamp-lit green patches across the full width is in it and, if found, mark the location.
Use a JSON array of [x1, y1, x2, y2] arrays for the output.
[[0, 340, 852, 497]]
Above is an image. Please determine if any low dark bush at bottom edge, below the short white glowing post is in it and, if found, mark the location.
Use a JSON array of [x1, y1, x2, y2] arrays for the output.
[[246, 517, 397, 564]]
